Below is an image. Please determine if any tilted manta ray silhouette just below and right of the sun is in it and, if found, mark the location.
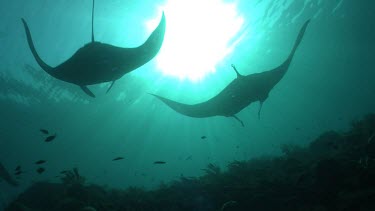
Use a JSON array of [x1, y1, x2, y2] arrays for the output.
[[152, 20, 310, 126]]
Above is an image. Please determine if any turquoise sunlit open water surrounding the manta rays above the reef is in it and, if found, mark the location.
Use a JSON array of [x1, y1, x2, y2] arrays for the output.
[[0, 0, 375, 208]]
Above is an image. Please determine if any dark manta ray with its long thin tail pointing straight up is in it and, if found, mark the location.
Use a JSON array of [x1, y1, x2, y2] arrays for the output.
[[22, 0, 165, 97]]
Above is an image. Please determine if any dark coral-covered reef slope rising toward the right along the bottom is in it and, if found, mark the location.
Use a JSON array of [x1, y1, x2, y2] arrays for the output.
[[6, 114, 375, 211]]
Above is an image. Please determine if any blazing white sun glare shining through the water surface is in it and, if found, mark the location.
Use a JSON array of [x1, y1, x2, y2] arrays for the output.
[[147, 0, 244, 81]]
